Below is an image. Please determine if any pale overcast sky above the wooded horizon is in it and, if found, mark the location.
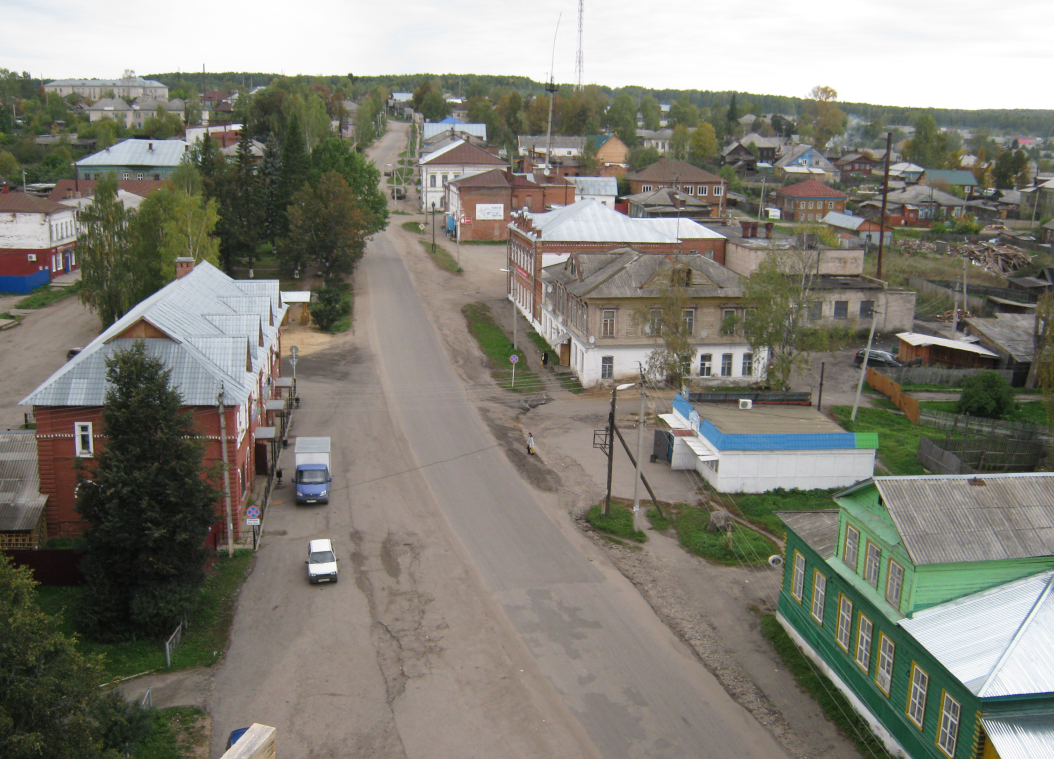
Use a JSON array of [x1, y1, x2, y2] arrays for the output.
[[0, 0, 1054, 109]]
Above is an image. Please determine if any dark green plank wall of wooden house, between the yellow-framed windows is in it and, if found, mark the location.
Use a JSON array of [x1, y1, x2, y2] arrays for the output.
[[779, 529, 980, 759]]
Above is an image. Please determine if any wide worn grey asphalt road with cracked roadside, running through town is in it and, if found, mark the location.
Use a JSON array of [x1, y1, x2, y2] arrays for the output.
[[210, 130, 786, 759]]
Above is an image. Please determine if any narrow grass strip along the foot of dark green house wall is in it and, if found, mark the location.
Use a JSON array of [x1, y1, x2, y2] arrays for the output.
[[761, 615, 893, 759]]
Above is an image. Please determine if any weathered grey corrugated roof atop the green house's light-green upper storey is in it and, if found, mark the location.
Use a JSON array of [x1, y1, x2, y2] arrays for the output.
[[874, 473, 1054, 565]]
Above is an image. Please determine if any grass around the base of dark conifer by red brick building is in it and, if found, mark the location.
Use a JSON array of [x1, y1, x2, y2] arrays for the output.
[[37, 550, 253, 678]]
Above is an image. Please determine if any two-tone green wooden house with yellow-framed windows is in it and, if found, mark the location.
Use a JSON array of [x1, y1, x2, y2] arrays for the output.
[[778, 473, 1054, 759]]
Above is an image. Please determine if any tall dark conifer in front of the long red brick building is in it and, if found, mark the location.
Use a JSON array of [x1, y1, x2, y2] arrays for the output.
[[77, 340, 219, 640]]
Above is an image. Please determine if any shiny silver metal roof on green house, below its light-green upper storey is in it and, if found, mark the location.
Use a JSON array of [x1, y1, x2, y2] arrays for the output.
[[897, 571, 1054, 698]]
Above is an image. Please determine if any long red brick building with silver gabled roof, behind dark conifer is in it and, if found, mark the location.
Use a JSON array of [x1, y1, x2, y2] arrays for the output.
[[21, 259, 287, 539]]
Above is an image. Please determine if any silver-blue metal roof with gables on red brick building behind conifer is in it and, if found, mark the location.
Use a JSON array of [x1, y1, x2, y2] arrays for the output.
[[20, 262, 288, 406]]
